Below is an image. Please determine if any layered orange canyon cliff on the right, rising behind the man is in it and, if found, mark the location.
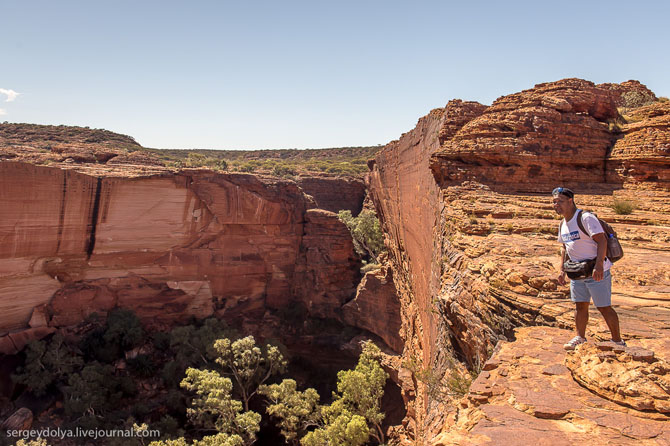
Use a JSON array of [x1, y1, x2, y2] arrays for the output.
[[370, 79, 670, 444]]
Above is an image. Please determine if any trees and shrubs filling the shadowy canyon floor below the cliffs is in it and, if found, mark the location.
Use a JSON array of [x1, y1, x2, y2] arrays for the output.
[[0, 309, 388, 446]]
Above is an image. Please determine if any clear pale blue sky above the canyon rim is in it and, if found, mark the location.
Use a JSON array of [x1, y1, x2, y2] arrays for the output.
[[0, 0, 670, 149]]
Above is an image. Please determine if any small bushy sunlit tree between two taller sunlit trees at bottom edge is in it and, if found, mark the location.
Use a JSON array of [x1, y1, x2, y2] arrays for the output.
[[258, 379, 319, 444]]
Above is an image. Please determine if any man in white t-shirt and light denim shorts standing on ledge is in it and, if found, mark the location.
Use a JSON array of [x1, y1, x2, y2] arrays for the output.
[[552, 187, 626, 350]]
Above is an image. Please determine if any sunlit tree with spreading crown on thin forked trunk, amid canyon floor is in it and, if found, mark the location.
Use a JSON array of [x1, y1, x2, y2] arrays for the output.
[[214, 336, 287, 411]]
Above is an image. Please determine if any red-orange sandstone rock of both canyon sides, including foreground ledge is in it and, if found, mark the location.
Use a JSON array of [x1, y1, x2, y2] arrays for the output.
[[0, 79, 670, 445]]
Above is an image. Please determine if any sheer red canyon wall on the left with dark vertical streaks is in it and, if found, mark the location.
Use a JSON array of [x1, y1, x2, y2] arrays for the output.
[[0, 161, 399, 353]]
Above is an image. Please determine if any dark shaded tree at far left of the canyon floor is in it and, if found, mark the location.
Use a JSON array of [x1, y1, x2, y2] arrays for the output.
[[12, 333, 83, 396]]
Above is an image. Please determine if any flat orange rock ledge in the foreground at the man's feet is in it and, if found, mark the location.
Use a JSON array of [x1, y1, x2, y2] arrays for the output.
[[429, 327, 670, 446]]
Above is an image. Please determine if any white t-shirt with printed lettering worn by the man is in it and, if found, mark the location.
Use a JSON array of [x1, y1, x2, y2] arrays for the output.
[[558, 209, 612, 271]]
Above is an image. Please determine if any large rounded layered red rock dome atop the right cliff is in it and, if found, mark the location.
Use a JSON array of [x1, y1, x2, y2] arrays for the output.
[[431, 79, 618, 191]]
